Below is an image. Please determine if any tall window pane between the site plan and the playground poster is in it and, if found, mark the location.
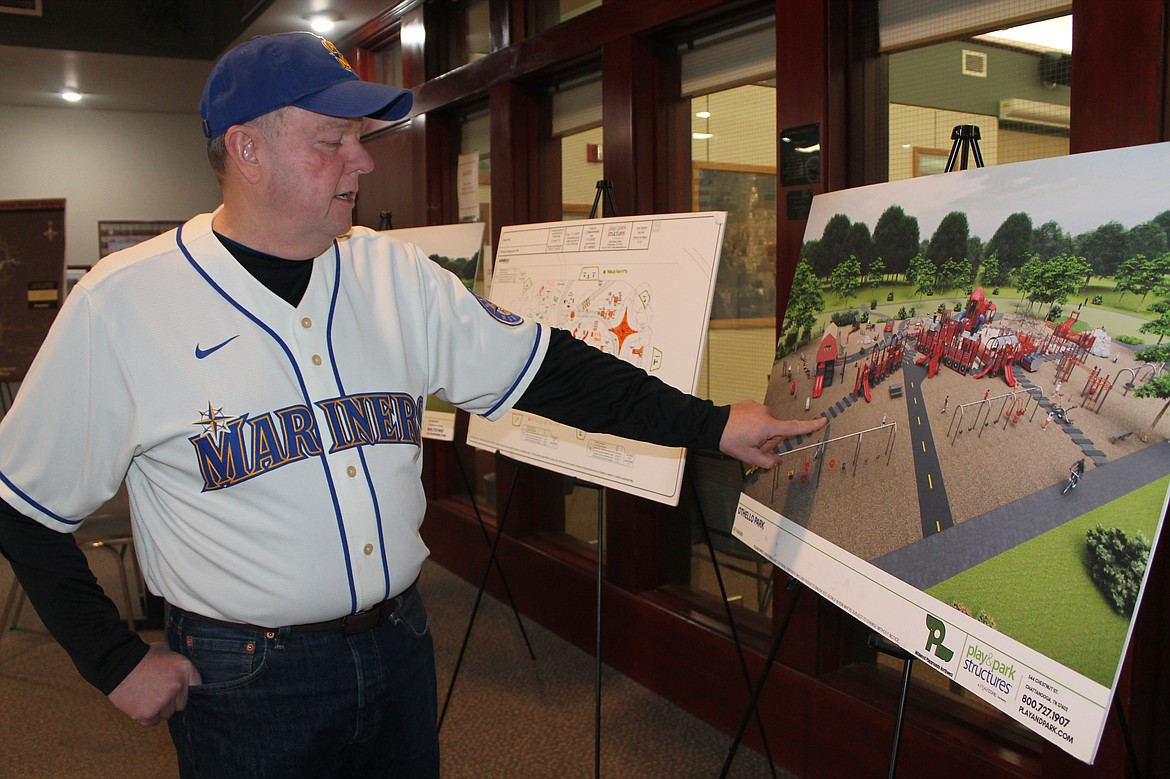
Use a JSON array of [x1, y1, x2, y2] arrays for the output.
[[682, 31, 777, 614]]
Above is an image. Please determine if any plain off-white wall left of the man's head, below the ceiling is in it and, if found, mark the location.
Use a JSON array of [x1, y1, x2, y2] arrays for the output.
[[0, 105, 220, 266]]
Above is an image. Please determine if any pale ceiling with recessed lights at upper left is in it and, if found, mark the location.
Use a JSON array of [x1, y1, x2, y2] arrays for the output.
[[0, 0, 393, 113]]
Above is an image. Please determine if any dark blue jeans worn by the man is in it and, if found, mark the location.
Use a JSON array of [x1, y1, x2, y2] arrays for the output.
[[167, 591, 439, 779]]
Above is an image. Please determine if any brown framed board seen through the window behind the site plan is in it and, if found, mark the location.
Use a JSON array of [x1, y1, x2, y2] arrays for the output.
[[691, 161, 776, 328]]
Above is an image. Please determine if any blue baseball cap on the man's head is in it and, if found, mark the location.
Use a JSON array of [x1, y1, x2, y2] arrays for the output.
[[199, 33, 414, 138]]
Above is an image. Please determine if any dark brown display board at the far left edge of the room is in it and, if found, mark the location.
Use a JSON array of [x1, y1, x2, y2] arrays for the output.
[[0, 200, 66, 381]]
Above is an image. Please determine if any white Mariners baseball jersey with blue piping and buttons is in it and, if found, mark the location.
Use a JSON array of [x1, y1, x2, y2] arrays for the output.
[[0, 214, 548, 626]]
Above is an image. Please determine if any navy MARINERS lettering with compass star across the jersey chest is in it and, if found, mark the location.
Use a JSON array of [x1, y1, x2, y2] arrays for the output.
[[188, 392, 422, 492]]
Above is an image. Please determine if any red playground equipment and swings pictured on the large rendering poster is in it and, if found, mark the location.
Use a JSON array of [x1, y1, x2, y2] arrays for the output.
[[755, 289, 1168, 514]]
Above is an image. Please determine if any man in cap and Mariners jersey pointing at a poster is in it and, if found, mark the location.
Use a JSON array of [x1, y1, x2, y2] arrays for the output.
[[0, 33, 825, 779]]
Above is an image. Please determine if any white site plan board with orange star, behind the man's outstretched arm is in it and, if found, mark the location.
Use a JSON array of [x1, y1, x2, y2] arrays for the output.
[[467, 212, 727, 505]]
